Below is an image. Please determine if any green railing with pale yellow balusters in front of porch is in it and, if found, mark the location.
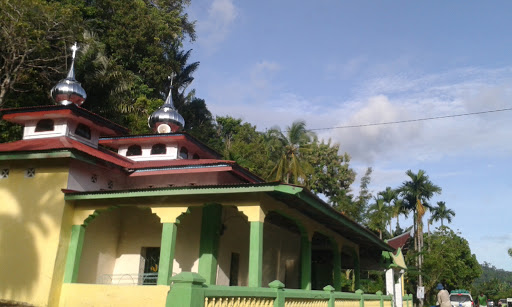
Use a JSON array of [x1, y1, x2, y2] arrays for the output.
[[166, 272, 412, 307]]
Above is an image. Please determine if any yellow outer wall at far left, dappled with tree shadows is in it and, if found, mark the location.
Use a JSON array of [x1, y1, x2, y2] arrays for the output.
[[0, 160, 69, 306]]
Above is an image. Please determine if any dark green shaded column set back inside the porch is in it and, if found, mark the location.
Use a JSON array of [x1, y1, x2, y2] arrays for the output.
[[198, 204, 222, 285]]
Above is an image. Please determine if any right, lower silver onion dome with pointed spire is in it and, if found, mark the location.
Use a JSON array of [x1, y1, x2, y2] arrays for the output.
[[148, 79, 185, 133]]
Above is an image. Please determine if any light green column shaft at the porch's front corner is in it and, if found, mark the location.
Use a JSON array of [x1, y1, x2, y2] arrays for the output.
[[248, 222, 263, 287]]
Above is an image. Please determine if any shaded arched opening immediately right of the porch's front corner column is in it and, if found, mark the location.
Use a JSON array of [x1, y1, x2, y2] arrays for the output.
[[262, 212, 301, 289]]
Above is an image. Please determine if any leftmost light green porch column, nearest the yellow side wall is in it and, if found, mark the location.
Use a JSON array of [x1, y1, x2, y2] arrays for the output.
[[64, 225, 85, 283]]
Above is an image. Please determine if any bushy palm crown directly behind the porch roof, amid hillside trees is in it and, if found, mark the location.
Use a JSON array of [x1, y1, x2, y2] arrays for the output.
[[268, 120, 316, 185]]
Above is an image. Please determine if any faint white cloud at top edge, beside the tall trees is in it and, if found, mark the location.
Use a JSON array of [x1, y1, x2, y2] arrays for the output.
[[197, 0, 238, 52]]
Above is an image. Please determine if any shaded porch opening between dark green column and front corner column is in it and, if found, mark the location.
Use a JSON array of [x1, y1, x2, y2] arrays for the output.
[[216, 206, 250, 286]]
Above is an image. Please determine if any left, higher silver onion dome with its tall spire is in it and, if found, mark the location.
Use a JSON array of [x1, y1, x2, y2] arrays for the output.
[[50, 43, 87, 106]]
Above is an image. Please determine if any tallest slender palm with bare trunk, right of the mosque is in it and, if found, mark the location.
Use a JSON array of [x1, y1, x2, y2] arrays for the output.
[[399, 169, 441, 307]]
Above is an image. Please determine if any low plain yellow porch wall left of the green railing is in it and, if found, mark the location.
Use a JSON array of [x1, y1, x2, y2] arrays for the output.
[[59, 284, 169, 307]]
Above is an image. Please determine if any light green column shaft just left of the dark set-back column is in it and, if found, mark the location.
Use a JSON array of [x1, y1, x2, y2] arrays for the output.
[[156, 223, 177, 285]]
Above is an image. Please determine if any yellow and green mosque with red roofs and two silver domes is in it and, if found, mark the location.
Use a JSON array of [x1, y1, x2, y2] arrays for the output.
[[0, 45, 405, 307]]
